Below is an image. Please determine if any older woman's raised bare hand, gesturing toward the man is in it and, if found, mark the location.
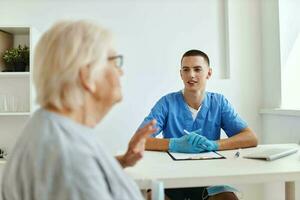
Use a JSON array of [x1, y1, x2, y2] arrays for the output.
[[116, 120, 156, 168]]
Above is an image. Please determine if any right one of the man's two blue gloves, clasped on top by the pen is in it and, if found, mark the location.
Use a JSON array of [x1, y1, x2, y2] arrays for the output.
[[189, 129, 219, 151]]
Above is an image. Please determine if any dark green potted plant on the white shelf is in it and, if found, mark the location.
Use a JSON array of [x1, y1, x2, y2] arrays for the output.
[[2, 45, 29, 72]]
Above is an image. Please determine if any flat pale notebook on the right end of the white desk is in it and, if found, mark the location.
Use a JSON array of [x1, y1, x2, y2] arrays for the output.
[[243, 147, 298, 161]]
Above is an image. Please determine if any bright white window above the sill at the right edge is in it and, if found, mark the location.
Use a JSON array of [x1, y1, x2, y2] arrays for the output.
[[279, 0, 300, 109]]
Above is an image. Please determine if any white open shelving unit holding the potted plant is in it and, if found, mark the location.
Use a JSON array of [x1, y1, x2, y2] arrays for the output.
[[0, 26, 33, 116]]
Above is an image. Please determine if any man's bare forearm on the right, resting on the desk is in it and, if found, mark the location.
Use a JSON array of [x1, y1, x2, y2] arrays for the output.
[[217, 128, 257, 150]]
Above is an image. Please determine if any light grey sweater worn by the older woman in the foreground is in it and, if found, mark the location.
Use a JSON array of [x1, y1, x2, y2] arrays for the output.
[[2, 109, 142, 200]]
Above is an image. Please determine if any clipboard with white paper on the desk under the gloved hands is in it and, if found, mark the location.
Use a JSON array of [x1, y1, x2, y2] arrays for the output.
[[167, 151, 226, 161]]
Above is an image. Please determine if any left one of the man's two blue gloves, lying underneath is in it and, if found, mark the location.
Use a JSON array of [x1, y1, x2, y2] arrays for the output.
[[169, 133, 205, 153]]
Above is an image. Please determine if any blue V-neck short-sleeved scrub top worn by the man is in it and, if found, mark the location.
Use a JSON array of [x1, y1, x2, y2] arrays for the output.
[[140, 91, 247, 140]]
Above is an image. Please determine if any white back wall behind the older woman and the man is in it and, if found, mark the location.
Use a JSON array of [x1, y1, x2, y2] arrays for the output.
[[0, 0, 263, 199]]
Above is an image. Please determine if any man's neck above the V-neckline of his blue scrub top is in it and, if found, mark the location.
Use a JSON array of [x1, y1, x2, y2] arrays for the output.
[[183, 89, 205, 110]]
